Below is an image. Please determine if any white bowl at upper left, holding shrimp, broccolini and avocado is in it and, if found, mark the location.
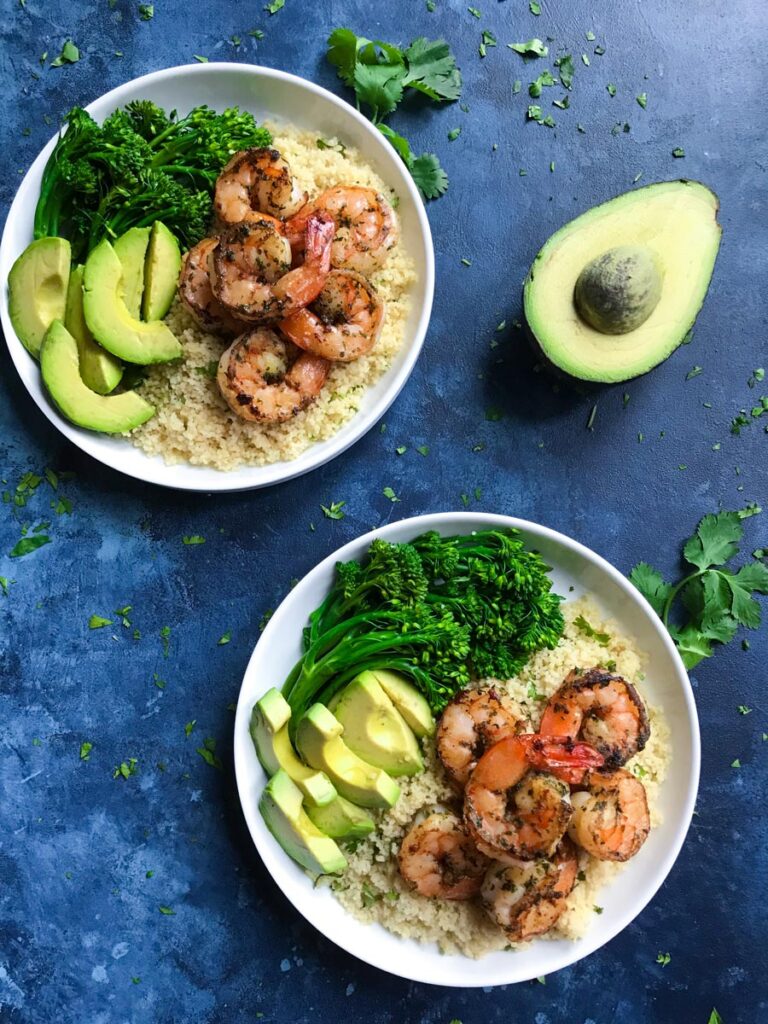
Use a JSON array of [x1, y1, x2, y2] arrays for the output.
[[0, 63, 434, 492]]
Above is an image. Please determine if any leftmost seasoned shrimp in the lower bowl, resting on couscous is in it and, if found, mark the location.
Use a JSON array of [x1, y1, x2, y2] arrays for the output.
[[397, 813, 488, 899]]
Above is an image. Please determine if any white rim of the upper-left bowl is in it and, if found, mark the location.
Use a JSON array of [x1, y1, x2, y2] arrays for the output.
[[0, 60, 435, 494]]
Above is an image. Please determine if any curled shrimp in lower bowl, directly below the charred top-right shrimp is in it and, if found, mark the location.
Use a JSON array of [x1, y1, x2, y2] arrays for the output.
[[568, 768, 650, 860]]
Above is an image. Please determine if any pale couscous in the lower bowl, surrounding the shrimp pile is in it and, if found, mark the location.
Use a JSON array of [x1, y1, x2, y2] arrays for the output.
[[332, 598, 670, 957]]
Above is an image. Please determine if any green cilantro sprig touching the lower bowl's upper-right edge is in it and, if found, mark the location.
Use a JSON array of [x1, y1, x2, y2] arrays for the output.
[[630, 512, 768, 669]]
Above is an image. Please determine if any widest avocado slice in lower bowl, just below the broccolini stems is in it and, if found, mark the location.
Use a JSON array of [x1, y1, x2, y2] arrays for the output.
[[328, 672, 424, 776]]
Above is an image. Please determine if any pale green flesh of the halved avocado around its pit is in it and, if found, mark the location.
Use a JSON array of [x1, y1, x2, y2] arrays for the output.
[[523, 180, 721, 383]]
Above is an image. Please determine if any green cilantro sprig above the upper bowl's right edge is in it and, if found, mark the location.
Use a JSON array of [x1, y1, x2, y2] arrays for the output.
[[326, 29, 462, 199]]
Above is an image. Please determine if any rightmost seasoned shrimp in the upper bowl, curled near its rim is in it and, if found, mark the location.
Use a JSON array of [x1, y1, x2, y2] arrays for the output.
[[286, 185, 400, 276]]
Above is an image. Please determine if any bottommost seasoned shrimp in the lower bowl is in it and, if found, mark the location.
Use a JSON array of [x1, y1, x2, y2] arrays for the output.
[[480, 839, 579, 942]]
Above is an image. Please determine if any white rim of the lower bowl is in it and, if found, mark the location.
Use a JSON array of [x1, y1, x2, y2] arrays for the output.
[[233, 512, 701, 988]]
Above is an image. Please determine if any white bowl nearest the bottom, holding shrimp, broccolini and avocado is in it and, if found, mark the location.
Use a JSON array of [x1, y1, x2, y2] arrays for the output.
[[234, 512, 699, 987]]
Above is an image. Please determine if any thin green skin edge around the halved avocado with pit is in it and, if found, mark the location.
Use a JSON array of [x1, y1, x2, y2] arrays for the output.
[[522, 178, 722, 385]]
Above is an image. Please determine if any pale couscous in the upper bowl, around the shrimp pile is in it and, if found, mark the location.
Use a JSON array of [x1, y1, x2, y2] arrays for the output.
[[131, 125, 417, 471]]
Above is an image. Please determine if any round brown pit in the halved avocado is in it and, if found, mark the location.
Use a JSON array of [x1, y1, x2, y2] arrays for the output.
[[573, 246, 663, 335]]
